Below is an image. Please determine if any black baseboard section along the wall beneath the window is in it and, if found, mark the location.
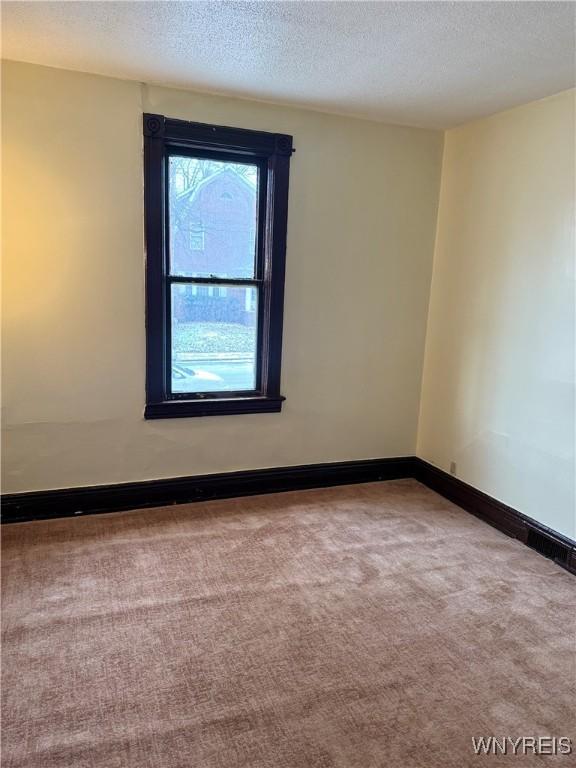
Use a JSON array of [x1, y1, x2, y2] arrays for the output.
[[2, 456, 414, 523]]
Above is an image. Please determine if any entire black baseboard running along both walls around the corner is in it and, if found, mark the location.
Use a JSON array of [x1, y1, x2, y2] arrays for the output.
[[2, 456, 576, 574]]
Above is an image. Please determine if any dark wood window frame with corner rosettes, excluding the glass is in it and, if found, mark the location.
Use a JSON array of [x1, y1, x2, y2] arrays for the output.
[[144, 114, 294, 419]]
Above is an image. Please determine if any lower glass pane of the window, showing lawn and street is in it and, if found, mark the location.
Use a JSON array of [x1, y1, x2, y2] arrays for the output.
[[172, 283, 258, 393]]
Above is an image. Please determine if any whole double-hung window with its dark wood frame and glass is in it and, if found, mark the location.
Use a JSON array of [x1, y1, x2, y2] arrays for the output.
[[144, 114, 293, 419]]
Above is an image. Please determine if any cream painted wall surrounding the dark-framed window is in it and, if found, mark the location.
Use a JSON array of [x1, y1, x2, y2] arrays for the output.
[[2, 62, 443, 492]]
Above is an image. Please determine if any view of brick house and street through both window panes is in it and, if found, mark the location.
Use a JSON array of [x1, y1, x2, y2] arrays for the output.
[[168, 155, 258, 394]]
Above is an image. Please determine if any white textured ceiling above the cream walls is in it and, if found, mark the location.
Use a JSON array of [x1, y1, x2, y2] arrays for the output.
[[2, 0, 576, 128]]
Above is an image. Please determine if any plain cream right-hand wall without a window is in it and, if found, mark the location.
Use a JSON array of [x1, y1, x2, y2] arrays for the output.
[[418, 91, 576, 538]]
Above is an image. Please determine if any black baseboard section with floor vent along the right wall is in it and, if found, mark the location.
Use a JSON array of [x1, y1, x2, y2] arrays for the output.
[[414, 458, 576, 574]]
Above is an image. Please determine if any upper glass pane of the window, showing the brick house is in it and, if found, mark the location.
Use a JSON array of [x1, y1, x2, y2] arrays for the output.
[[168, 155, 258, 277]]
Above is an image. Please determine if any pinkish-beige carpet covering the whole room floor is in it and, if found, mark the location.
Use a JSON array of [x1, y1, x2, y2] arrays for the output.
[[2, 480, 576, 768]]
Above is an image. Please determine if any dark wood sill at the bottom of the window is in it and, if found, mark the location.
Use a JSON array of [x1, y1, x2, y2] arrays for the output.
[[144, 395, 286, 419]]
